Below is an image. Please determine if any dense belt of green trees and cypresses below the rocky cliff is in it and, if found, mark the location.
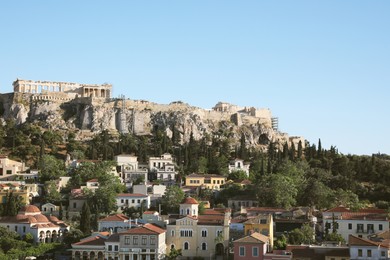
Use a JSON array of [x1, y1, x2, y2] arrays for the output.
[[0, 120, 390, 211]]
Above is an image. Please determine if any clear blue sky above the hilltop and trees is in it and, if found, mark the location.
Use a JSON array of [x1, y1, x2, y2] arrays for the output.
[[0, 0, 390, 155]]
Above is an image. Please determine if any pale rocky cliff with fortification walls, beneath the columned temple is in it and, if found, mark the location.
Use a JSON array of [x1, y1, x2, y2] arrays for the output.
[[0, 93, 304, 148]]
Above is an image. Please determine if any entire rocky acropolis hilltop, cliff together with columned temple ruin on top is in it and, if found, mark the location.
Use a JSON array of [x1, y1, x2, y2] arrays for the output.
[[0, 79, 304, 149]]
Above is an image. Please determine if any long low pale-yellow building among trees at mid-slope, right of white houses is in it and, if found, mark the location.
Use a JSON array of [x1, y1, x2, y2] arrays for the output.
[[185, 173, 226, 190]]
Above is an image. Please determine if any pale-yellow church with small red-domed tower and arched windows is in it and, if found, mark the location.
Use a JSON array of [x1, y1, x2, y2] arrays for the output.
[[166, 197, 230, 259]]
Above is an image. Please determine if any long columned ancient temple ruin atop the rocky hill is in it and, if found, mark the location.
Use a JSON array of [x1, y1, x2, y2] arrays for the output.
[[12, 79, 112, 98]]
